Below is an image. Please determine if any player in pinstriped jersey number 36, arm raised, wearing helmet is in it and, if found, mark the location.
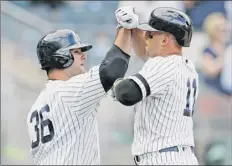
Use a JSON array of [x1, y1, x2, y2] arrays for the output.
[[27, 28, 137, 165]]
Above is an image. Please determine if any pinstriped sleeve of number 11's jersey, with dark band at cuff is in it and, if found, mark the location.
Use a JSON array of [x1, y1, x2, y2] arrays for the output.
[[129, 57, 176, 99]]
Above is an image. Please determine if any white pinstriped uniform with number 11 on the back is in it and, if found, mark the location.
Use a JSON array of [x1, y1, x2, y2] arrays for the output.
[[129, 55, 198, 165]]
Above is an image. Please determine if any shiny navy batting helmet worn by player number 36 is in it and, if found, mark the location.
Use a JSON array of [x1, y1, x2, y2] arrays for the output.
[[37, 29, 92, 70]]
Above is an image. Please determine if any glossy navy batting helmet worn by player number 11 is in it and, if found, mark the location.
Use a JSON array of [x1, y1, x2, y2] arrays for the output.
[[137, 7, 193, 47]]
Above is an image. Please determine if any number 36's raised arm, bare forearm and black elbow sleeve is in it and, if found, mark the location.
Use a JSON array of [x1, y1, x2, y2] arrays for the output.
[[99, 28, 134, 92]]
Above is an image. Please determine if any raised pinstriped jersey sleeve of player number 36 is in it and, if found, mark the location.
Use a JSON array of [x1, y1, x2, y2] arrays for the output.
[[58, 66, 106, 113]]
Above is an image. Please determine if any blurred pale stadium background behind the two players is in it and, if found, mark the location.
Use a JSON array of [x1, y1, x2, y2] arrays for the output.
[[1, 0, 232, 165]]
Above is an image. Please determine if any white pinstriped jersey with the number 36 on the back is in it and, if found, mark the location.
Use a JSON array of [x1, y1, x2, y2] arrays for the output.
[[27, 66, 106, 165]]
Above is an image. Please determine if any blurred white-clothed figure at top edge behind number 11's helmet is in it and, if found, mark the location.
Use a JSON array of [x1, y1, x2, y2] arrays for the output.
[[119, 1, 185, 22]]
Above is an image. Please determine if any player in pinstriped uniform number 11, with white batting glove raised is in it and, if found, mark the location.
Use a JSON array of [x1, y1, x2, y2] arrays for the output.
[[112, 7, 198, 165]]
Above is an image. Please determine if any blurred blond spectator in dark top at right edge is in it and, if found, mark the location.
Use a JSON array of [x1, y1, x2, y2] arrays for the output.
[[201, 13, 230, 94]]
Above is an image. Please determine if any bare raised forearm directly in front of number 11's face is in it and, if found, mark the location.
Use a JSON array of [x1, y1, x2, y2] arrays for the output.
[[132, 28, 147, 61]]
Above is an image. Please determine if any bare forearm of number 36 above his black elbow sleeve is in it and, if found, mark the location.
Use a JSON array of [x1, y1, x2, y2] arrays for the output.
[[114, 28, 131, 55]]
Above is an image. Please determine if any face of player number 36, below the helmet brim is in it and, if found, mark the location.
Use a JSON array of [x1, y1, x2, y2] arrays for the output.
[[70, 48, 86, 75]]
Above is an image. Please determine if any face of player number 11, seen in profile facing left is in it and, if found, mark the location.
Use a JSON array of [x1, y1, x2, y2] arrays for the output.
[[145, 31, 164, 57]]
